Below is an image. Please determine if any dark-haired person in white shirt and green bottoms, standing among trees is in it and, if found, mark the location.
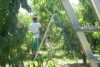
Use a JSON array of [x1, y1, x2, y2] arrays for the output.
[[29, 17, 41, 58]]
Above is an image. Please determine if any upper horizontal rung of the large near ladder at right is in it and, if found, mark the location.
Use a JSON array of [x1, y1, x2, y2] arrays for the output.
[[76, 27, 100, 32]]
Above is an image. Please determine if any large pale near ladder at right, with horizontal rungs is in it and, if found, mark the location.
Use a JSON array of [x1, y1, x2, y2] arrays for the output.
[[61, 0, 100, 67]]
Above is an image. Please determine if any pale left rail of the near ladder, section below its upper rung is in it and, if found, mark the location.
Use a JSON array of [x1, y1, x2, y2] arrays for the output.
[[77, 32, 98, 67]]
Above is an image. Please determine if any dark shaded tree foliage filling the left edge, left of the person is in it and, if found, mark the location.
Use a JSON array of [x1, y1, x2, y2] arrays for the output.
[[0, 0, 30, 67]]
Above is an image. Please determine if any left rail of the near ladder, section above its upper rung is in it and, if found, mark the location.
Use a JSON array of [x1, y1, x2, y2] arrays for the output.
[[61, 0, 81, 30]]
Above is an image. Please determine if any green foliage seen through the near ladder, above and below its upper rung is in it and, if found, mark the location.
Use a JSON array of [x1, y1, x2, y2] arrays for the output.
[[79, 0, 100, 52]]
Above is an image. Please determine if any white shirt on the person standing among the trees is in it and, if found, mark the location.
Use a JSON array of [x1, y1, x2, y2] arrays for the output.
[[29, 22, 41, 38]]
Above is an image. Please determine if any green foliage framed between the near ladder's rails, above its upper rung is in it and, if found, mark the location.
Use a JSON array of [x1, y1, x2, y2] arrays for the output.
[[79, 0, 97, 27]]
